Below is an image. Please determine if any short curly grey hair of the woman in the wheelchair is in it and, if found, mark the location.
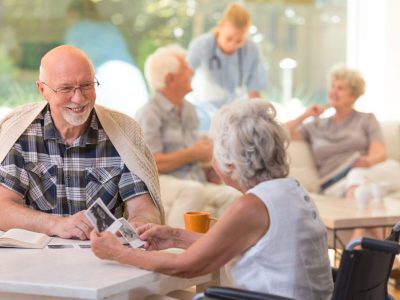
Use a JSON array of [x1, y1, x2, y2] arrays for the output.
[[210, 99, 289, 190]]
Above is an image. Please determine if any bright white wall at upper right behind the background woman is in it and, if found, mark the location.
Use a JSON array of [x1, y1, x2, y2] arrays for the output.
[[347, 0, 400, 120]]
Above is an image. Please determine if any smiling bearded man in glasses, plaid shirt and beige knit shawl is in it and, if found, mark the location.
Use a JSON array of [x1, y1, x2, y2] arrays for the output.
[[0, 45, 164, 240]]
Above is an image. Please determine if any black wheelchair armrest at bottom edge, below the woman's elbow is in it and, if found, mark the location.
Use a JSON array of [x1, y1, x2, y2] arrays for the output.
[[204, 287, 293, 300]]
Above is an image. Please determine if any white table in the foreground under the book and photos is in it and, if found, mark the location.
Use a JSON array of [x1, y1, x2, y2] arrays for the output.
[[0, 239, 218, 299]]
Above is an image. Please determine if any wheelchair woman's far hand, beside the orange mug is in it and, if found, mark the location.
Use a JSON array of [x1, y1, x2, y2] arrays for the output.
[[136, 223, 179, 250]]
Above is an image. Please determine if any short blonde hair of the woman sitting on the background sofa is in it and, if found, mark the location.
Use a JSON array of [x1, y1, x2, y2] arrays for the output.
[[328, 64, 365, 98]]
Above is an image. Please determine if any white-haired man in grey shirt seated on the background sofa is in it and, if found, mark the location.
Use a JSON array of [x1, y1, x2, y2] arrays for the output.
[[137, 45, 241, 227]]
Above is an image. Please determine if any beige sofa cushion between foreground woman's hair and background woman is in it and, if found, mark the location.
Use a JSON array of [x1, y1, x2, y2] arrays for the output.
[[288, 140, 319, 193]]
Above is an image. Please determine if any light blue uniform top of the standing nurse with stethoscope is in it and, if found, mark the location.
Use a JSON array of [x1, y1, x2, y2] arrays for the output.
[[187, 32, 267, 130]]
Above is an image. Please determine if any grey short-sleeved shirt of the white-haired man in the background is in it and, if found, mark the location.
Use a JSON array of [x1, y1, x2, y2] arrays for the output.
[[136, 93, 207, 182]]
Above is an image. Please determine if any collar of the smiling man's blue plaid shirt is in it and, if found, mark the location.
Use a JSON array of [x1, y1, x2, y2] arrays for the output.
[[43, 105, 101, 147]]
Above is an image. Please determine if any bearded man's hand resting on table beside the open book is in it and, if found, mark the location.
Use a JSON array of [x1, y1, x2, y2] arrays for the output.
[[53, 211, 93, 240]]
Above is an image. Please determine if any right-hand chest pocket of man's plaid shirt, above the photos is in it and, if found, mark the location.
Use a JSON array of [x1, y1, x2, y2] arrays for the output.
[[86, 167, 122, 206]]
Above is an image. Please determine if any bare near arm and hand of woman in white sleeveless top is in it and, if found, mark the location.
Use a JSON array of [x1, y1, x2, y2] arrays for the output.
[[91, 194, 269, 277]]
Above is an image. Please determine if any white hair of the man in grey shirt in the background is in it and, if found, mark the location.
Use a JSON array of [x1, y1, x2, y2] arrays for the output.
[[144, 44, 186, 91]]
